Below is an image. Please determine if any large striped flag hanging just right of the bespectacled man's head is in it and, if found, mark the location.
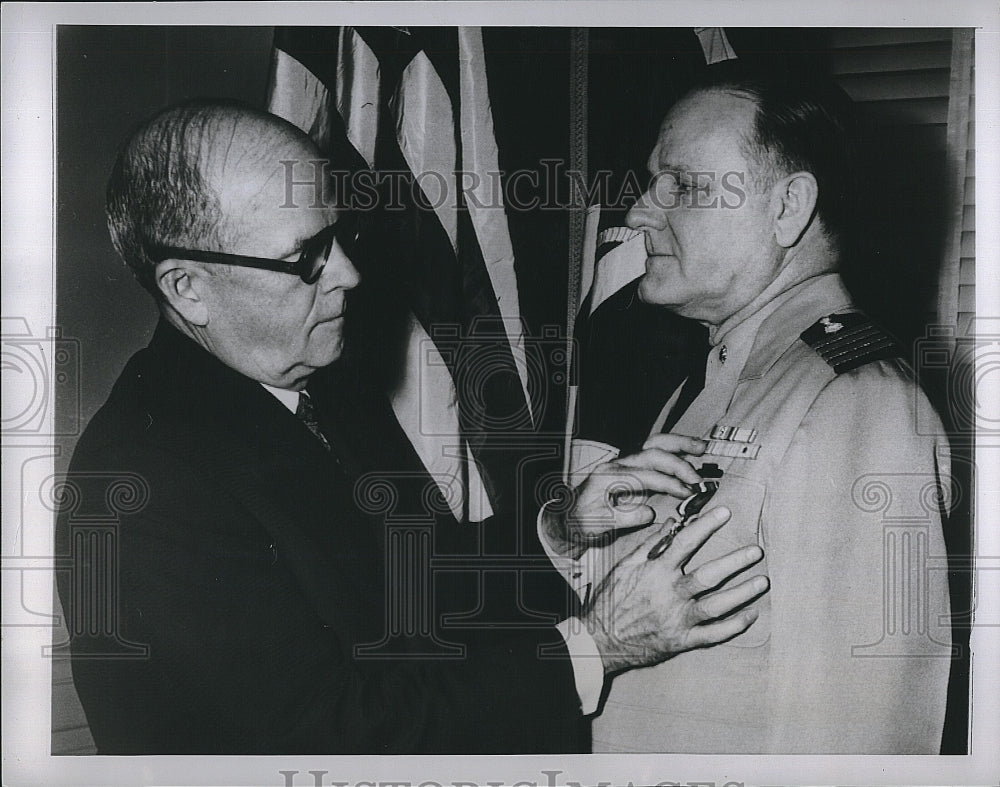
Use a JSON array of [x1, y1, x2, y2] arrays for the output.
[[268, 27, 533, 522]]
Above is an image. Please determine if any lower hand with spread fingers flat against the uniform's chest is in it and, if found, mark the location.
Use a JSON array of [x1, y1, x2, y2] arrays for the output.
[[582, 508, 768, 674]]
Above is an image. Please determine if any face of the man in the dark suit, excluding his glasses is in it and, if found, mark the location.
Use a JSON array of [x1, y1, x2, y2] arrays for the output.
[[201, 139, 358, 389]]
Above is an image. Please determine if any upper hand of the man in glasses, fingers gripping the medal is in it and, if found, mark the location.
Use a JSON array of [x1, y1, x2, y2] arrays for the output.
[[542, 434, 707, 559]]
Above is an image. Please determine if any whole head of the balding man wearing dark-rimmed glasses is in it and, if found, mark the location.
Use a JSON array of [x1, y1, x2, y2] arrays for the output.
[[108, 101, 358, 389]]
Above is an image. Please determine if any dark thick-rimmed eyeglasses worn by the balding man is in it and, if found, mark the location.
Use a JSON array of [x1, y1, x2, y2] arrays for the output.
[[149, 211, 362, 284]]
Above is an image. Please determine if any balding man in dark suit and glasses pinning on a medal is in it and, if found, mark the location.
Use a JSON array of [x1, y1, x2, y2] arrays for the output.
[[57, 102, 766, 754]]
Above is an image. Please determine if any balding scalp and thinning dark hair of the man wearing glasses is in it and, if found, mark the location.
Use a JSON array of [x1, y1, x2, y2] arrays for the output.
[[107, 101, 308, 298]]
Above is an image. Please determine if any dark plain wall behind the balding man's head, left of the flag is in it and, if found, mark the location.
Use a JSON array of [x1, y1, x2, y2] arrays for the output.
[[56, 26, 273, 472]]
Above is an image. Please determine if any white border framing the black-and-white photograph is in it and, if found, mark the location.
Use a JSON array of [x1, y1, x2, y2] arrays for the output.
[[0, 0, 1000, 787]]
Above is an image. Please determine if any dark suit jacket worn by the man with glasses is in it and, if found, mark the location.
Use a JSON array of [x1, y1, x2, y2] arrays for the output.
[[57, 324, 579, 754]]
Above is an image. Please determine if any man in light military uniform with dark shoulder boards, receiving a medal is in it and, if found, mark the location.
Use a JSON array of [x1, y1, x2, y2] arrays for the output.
[[540, 66, 950, 754]]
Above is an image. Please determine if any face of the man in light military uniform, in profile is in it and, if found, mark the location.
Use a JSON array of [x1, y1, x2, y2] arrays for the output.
[[626, 91, 781, 325]]
